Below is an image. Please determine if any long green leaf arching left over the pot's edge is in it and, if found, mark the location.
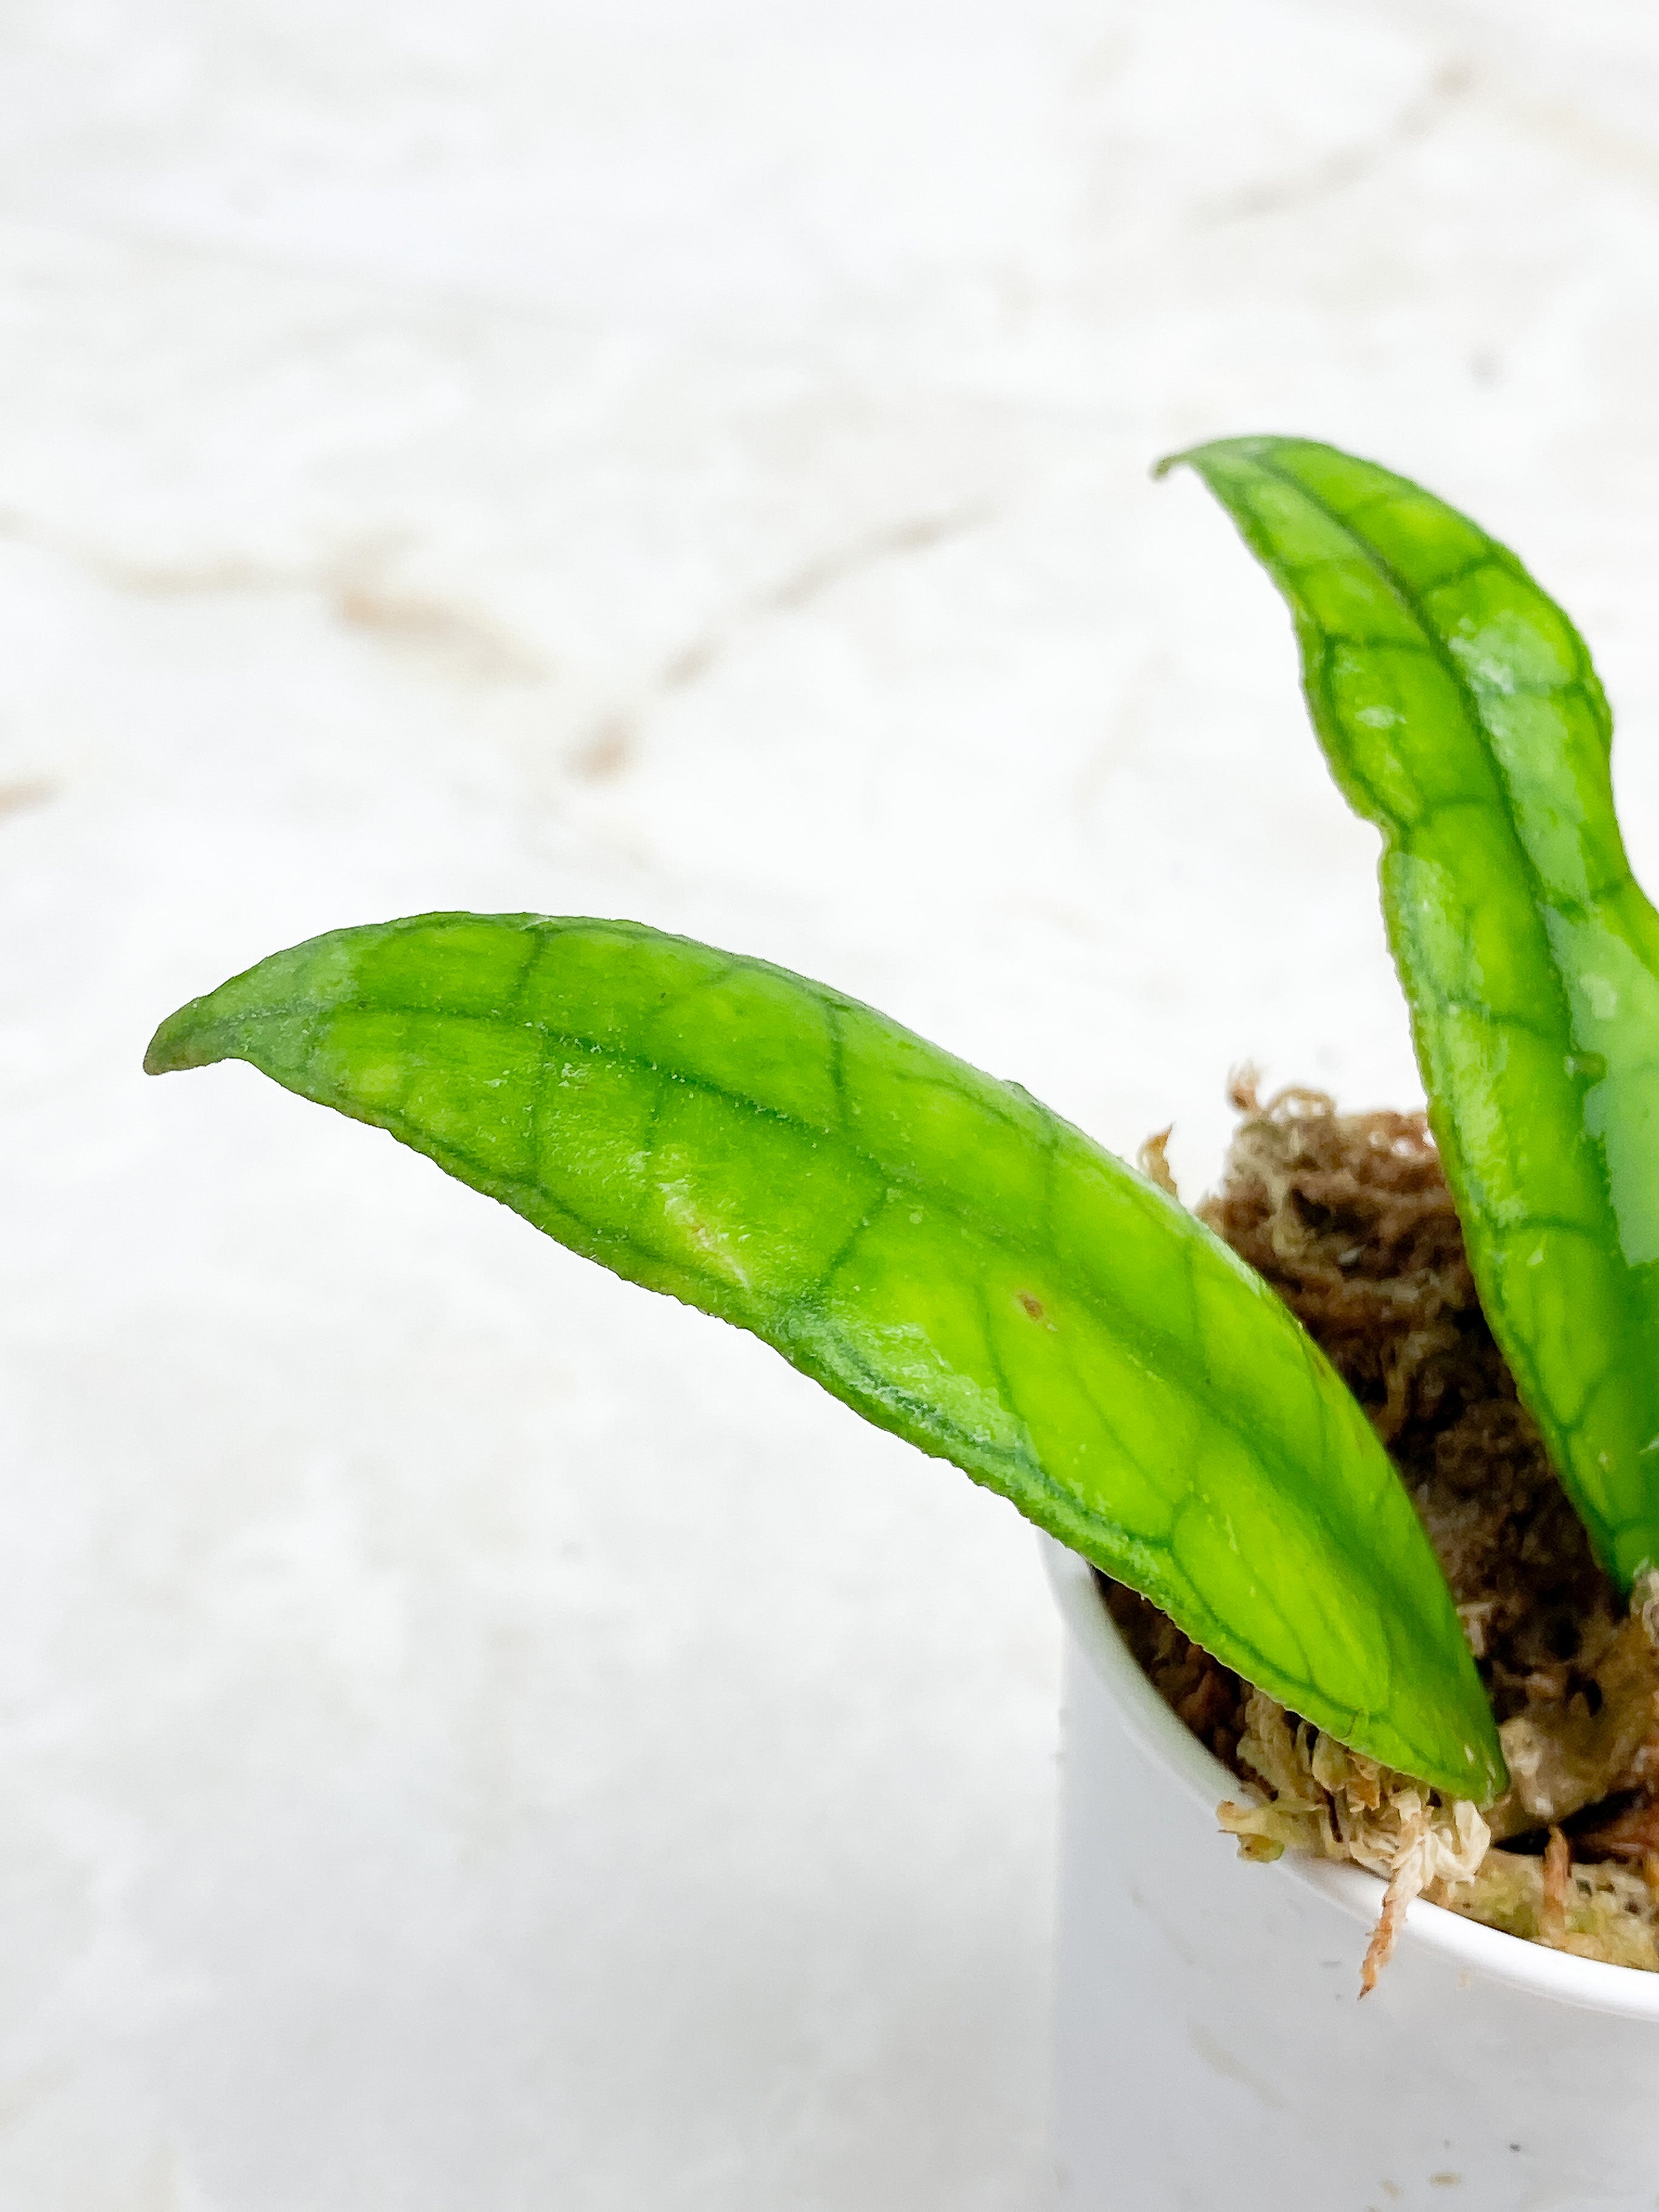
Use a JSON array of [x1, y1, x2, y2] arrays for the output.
[[146, 914, 1504, 1801]]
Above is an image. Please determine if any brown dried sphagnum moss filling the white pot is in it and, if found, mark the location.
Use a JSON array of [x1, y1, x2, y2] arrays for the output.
[[1108, 1075, 1659, 1988]]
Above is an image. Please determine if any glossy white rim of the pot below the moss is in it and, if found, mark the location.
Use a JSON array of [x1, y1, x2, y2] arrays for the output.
[[1042, 1535, 1659, 2019]]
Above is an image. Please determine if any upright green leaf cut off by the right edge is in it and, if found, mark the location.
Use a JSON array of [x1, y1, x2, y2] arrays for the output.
[[1163, 438, 1659, 1588]]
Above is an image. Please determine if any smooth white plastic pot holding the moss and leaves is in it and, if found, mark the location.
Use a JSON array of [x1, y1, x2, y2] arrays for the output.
[[1044, 1544, 1659, 2212]]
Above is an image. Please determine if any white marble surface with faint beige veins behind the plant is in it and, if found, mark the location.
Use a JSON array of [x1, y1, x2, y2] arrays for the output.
[[0, 0, 1659, 2212]]
